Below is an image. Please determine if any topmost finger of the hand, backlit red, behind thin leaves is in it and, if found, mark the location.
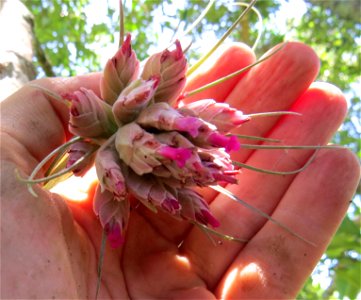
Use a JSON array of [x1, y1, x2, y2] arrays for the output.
[[183, 43, 255, 103]]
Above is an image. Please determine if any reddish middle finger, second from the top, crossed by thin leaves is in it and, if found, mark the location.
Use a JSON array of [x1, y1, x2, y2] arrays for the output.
[[204, 43, 319, 202]]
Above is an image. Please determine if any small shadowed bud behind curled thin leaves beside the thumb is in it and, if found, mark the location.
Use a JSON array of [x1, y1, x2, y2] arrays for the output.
[[66, 141, 98, 177]]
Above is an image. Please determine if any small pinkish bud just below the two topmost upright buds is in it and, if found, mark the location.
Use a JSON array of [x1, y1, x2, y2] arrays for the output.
[[113, 78, 159, 126]]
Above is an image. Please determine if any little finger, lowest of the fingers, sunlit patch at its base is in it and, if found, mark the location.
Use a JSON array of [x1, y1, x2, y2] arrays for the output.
[[218, 150, 360, 299]]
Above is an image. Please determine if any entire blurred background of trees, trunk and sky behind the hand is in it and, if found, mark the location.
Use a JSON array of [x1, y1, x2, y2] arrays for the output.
[[0, 0, 361, 299]]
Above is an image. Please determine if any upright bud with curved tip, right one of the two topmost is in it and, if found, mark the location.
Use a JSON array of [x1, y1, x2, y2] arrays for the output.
[[141, 41, 187, 103]]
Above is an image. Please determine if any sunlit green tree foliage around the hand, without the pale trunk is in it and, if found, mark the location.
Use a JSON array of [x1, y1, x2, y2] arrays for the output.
[[23, 0, 361, 299]]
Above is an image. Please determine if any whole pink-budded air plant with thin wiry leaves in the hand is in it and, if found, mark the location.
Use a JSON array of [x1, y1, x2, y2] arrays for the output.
[[17, 1, 344, 296]]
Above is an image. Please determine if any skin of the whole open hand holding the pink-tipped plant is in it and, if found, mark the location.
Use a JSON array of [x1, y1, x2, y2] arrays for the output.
[[1, 43, 360, 299]]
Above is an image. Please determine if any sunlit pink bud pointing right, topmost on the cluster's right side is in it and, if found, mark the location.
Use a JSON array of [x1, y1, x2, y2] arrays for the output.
[[180, 99, 250, 132]]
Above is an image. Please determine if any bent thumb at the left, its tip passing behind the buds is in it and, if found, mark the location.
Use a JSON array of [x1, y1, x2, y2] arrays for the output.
[[1, 73, 100, 164]]
